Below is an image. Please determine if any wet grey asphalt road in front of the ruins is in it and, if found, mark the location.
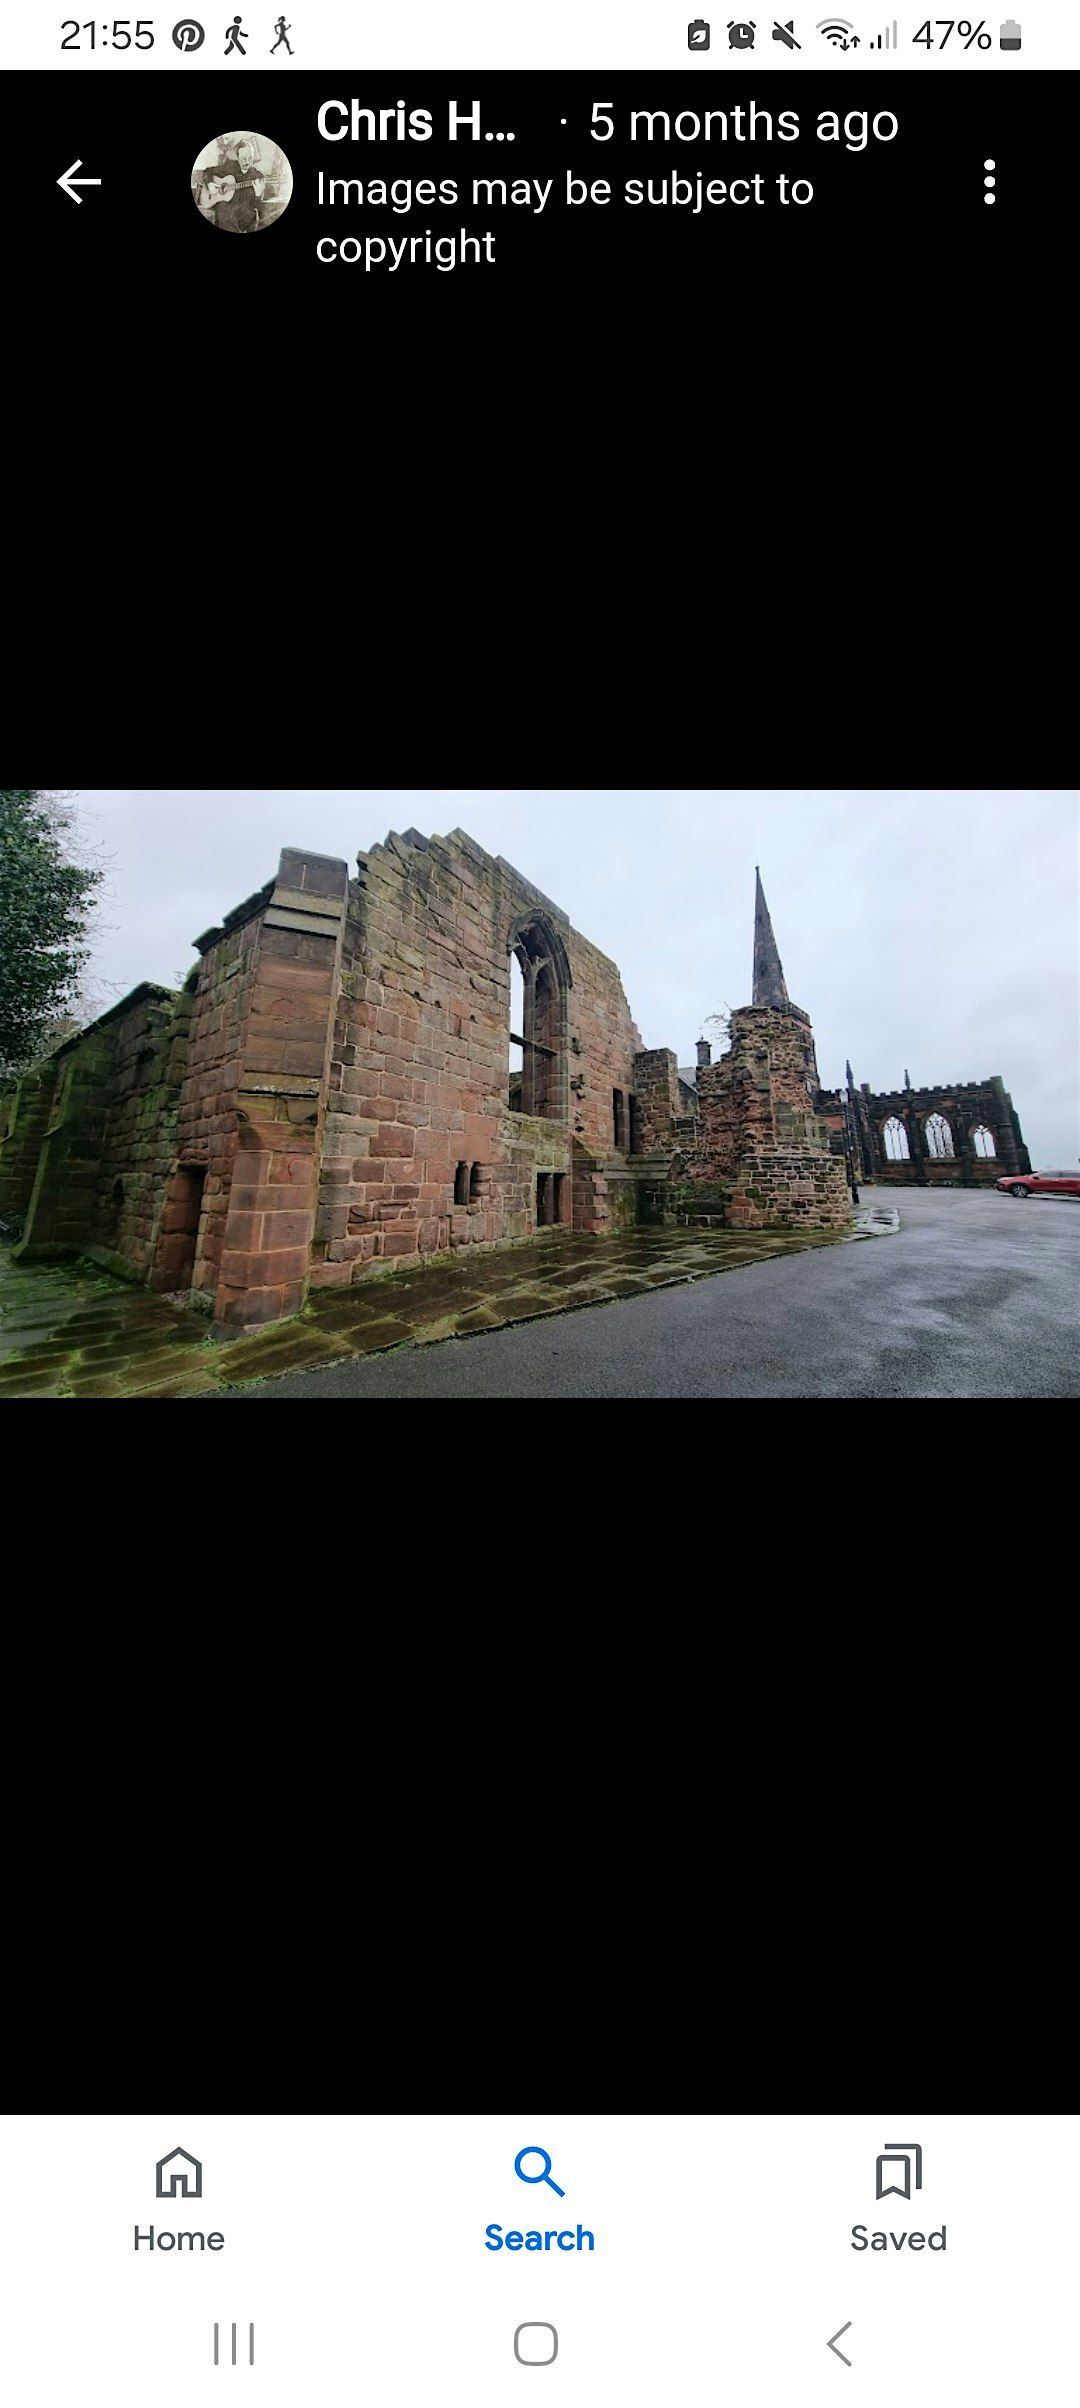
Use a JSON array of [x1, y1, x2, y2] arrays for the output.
[[245, 1187, 1080, 1397]]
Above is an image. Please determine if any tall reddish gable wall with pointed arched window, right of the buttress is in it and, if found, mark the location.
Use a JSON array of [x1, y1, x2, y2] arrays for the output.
[[310, 828, 640, 1286]]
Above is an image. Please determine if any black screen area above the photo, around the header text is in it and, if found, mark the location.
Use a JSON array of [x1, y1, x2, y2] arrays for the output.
[[7, 65, 1070, 787]]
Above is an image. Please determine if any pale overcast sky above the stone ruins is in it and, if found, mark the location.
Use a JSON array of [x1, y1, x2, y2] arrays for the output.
[[77, 790, 1080, 1168]]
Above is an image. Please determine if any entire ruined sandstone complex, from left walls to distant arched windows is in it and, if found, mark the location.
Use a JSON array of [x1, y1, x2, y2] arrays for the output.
[[0, 828, 1029, 1334]]
